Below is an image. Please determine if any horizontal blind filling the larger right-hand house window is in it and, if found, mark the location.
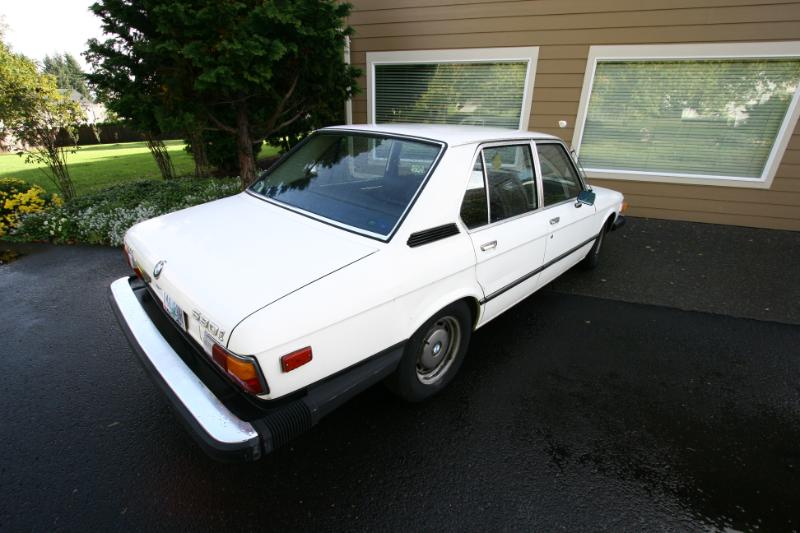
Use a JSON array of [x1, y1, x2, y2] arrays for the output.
[[580, 59, 800, 178]]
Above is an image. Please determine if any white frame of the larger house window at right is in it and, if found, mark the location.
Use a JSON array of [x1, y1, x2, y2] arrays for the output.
[[572, 41, 800, 189]]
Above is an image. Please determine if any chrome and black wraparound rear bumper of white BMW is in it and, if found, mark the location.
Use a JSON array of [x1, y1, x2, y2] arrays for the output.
[[110, 278, 403, 461]]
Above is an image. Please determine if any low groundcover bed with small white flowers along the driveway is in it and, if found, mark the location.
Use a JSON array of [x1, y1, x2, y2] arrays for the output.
[[12, 178, 240, 246]]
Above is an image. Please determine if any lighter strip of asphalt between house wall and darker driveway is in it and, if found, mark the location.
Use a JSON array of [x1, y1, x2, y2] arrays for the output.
[[552, 217, 800, 324]]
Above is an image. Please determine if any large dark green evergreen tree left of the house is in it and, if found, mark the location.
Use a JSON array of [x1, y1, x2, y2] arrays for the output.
[[87, 0, 358, 185]]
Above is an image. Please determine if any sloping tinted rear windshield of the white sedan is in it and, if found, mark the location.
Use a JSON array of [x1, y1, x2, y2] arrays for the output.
[[251, 132, 441, 237]]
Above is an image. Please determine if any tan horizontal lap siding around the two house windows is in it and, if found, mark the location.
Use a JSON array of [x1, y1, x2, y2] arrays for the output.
[[349, 0, 800, 231]]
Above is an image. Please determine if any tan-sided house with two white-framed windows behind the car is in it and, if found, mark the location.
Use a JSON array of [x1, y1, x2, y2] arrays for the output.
[[348, 0, 800, 230]]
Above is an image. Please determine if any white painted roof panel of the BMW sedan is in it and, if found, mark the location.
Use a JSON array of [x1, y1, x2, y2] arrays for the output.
[[322, 124, 560, 146]]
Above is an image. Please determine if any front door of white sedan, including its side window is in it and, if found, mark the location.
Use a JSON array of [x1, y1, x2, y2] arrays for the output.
[[535, 141, 597, 285]]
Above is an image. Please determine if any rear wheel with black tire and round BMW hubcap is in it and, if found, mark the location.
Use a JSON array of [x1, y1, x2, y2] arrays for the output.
[[386, 302, 472, 402]]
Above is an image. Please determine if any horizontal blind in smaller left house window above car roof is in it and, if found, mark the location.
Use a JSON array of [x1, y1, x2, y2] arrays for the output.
[[375, 61, 528, 129]]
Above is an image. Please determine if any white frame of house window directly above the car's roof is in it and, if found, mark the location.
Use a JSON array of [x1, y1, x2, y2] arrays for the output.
[[367, 46, 539, 130]]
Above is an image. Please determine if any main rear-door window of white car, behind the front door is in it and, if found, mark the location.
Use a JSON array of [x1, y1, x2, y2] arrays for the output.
[[483, 144, 538, 222]]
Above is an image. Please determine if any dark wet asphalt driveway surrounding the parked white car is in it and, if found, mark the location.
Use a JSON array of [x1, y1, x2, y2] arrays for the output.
[[0, 220, 800, 531]]
